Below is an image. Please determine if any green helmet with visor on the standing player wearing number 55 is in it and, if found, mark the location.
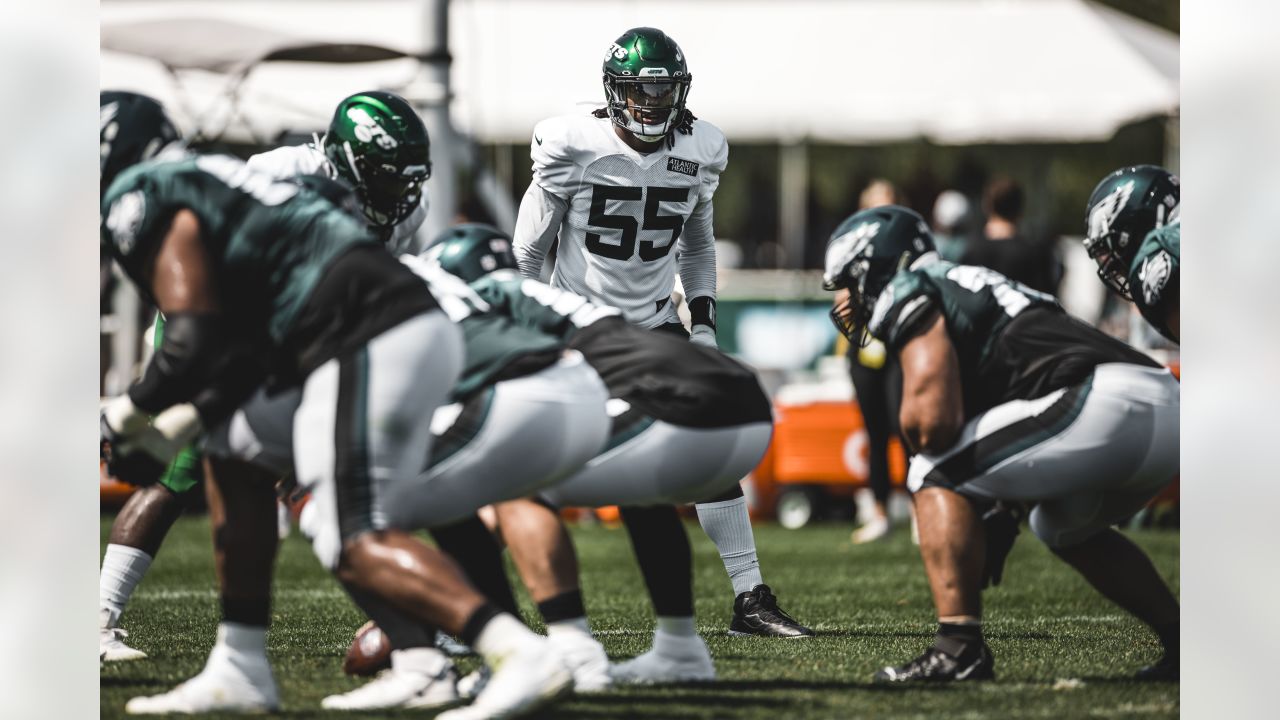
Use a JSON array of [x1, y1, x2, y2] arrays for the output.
[[603, 27, 694, 142]]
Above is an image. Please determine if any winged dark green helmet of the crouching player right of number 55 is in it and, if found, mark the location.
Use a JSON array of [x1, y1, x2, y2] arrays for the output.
[[822, 205, 936, 347]]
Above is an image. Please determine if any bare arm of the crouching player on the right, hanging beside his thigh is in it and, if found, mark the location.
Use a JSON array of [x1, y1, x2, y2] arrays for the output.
[[899, 311, 964, 455]]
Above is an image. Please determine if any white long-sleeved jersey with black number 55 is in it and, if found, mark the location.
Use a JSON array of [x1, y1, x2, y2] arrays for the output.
[[513, 113, 728, 328]]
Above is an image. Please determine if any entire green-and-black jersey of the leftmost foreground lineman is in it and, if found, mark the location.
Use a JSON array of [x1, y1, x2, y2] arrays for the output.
[[101, 155, 436, 397]]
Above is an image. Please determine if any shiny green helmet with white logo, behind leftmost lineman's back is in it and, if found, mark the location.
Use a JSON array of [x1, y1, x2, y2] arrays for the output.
[[320, 91, 431, 228]]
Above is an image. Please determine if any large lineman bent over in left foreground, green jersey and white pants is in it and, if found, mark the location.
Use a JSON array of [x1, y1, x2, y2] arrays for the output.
[[94, 96, 572, 714]]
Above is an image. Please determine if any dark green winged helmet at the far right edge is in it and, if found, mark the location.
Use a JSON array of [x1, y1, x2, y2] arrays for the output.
[[1084, 165, 1180, 300]]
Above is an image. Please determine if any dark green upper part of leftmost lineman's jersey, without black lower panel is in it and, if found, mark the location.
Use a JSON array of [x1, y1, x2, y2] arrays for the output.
[[101, 155, 378, 345]]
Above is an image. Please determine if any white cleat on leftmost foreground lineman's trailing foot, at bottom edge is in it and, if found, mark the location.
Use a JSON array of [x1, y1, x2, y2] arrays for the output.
[[436, 638, 573, 720]]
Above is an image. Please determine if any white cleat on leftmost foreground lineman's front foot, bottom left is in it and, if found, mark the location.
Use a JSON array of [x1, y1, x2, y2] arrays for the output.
[[124, 647, 280, 715]]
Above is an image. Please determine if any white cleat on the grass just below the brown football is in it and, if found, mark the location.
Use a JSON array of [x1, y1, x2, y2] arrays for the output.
[[320, 647, 458, 710]]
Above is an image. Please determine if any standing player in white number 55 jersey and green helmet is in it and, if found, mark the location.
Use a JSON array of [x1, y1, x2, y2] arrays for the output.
[[515, 27, 813, 637]]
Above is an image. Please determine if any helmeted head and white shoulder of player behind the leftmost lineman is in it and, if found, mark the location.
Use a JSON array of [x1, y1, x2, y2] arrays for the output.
[[248, 91, 431, 254]]
